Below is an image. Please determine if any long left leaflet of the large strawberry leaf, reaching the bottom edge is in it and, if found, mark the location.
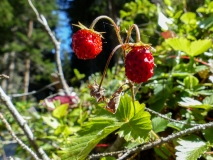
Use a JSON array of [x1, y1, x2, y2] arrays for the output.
[[60, 118, 122, 160]]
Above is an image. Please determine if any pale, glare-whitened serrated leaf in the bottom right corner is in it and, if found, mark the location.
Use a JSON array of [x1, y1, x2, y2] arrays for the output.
[[175, 135, 208, 160]]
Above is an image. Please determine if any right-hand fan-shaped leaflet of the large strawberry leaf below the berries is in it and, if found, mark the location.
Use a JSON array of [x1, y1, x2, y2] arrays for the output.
[[117, 104, 152, 143]]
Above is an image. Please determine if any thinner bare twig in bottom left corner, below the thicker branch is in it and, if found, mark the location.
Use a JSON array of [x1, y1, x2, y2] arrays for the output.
[[0, 113, 40, 160]]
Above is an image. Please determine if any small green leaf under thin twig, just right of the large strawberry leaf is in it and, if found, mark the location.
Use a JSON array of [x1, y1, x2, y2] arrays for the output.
[[152, 114, 171, 133]]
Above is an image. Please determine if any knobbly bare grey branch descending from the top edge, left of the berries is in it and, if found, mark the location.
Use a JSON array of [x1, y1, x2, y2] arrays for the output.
[[28, 0, 70, 95]]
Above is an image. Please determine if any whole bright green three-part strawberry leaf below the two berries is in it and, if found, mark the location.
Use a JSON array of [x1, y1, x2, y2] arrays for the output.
[[60, 95, 152, 159]]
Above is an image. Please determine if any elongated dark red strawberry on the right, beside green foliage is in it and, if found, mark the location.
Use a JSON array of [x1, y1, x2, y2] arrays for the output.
[[125, 46, 154, 83]]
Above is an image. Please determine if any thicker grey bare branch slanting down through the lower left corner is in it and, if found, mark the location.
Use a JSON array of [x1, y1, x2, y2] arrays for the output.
[[0, 87, 49, 160]]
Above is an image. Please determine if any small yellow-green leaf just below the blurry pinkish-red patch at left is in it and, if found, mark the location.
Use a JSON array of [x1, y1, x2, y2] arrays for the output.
[[52, 103, 69, 119]]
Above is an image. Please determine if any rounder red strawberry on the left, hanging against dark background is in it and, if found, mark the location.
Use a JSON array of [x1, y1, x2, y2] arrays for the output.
[[72, 29, 102, 60]]
